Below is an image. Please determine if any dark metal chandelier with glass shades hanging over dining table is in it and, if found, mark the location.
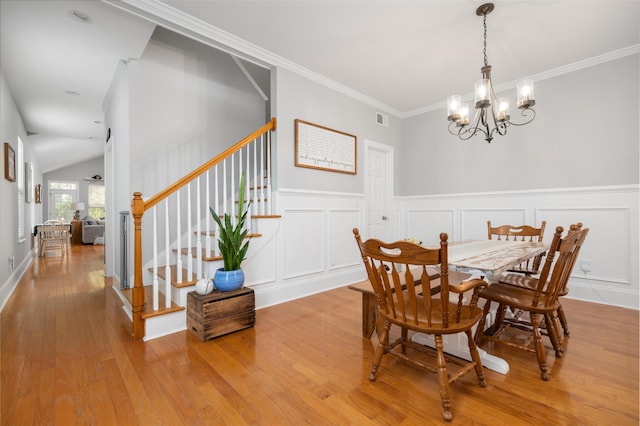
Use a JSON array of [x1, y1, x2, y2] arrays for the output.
[[447, 3, 536, 143]]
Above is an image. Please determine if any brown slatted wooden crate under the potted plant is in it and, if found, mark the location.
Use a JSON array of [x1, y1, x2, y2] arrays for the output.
[[187, 288, 256, 342]]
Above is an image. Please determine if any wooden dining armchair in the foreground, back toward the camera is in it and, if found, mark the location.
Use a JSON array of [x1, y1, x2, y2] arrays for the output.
[[353, 228, 488, 421]]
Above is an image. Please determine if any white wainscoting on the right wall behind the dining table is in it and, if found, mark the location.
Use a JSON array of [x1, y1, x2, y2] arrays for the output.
[[394, 185, 640, 309]]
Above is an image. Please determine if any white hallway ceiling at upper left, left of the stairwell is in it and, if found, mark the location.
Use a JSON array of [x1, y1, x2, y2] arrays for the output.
[[0, 0, 154, 173]]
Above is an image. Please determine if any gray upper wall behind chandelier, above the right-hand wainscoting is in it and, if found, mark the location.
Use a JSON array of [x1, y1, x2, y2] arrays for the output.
[[396, 54, 640, 195]]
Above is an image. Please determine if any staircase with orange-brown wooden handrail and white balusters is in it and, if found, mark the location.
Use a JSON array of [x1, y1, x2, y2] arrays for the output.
[[123, 119, 280, 340]]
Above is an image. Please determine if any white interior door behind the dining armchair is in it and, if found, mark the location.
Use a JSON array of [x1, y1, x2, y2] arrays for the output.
[[365, 140, 393, 241]]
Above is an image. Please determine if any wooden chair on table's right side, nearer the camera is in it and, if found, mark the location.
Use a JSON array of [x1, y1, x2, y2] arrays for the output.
[[476, 226, 589, 380]]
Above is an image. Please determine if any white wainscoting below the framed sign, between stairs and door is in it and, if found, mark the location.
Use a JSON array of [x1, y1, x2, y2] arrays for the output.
[[254, 189, 366, 308]]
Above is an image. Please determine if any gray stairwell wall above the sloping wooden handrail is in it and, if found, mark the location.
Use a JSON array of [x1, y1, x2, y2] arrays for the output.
[[128, 28, 268, 196]]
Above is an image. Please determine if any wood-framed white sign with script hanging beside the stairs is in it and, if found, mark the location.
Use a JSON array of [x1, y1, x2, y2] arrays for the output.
[[295, 119, 357, 175]]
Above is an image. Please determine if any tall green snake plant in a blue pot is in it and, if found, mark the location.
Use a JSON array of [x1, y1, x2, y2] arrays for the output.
[[209, 173, 251, 291]]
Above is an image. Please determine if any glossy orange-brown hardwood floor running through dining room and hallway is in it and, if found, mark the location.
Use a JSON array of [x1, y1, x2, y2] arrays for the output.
[[0, 246, 639, 425]]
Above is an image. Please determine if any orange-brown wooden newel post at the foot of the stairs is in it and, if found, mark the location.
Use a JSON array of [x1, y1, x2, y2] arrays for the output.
[[131, 192, 144, 340]]
